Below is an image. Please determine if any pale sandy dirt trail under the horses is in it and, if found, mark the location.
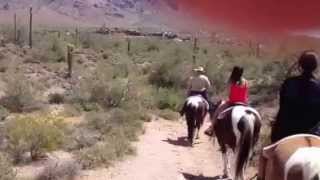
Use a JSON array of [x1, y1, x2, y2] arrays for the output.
[[80, 117, 252, 180]]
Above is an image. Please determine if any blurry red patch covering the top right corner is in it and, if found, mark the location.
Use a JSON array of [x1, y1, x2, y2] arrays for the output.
[[177, 0, 320, 33]]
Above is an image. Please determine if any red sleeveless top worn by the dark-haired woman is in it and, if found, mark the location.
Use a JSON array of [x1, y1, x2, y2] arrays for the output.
[[229, 81, 249, 104]]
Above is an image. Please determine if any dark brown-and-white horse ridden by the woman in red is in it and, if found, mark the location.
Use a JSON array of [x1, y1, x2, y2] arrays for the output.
[[213, 104, 261, 180]]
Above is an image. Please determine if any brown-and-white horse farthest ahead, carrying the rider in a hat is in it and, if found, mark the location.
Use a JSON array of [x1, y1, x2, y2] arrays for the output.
[[180, 95, 209, 146]]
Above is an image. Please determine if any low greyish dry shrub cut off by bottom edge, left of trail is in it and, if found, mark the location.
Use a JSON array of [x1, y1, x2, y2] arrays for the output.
[[36, 161, 80, 180]]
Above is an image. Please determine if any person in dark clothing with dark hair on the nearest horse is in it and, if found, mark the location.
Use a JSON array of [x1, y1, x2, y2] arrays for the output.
[[271, 51, 320, 143]]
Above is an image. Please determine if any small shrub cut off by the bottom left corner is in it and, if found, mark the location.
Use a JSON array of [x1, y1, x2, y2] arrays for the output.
[[0, 153, 16, 180]]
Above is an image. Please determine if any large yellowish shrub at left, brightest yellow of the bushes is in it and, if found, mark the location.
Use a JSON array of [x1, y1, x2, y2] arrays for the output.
[[6, 116, 65, 162]]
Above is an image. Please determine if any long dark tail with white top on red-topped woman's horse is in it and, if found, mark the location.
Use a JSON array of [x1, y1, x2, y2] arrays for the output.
[[235, 114, 254, 180]]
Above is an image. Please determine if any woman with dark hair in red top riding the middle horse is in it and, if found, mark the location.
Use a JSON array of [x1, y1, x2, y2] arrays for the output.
[[205, 66, 249, 136]]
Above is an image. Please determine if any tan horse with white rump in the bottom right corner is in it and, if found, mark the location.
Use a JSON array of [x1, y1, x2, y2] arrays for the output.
[[258, 134, 320, 180]]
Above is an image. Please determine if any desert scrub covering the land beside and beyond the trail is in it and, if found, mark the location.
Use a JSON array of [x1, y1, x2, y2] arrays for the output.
[[0, 27, 318, 179]]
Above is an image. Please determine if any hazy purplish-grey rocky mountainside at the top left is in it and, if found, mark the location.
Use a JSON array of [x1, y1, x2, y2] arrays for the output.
[[0, 0, 178, 26]]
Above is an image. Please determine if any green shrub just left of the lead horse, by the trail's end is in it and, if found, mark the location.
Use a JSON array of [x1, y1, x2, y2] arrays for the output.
[[154, 88, 184, 111]]
